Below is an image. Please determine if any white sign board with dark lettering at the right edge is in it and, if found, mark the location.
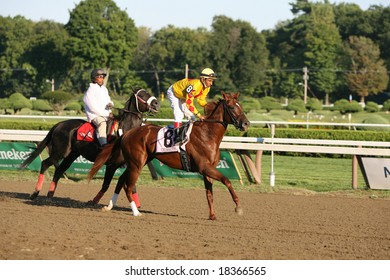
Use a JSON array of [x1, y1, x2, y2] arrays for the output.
[[361, 157, 390, 190]]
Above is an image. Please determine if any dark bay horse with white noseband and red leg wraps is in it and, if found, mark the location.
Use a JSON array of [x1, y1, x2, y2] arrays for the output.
[[21, 89, 160, 201]]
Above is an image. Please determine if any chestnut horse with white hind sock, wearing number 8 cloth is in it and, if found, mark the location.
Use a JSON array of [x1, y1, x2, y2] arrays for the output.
[[88, 92, 249, 220]]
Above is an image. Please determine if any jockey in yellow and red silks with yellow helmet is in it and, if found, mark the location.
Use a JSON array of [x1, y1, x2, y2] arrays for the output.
[[167, 68, 217, 128]]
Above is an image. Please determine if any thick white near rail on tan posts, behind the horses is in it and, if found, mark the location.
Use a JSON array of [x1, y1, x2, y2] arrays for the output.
[[0, 129, 390, 189]]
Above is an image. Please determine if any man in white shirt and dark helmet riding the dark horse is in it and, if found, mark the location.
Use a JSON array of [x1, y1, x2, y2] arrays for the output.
[[83, 69, 114, 146]]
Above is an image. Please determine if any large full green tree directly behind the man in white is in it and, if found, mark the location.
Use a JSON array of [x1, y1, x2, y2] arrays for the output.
[[65, 0, 138, 92]]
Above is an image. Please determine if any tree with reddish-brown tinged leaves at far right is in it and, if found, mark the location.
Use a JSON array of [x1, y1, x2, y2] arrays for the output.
[[346, 36, 389, 103]]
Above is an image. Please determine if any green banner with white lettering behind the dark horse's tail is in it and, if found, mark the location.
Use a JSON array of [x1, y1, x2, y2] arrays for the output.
[[0, 142, 41, 171]]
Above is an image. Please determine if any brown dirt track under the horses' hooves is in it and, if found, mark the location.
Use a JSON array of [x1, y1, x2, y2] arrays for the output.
[[0, 181, 390, 260]]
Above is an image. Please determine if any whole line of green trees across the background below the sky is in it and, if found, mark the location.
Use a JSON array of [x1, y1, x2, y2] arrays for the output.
[[0, 0, 390, 104]]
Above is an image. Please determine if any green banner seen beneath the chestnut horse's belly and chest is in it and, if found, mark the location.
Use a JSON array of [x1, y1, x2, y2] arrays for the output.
[[152, 151, 241, 180]]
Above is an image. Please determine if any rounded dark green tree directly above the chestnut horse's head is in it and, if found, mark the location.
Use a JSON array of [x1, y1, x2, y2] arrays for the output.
[[209, 16, 269, 95]]
